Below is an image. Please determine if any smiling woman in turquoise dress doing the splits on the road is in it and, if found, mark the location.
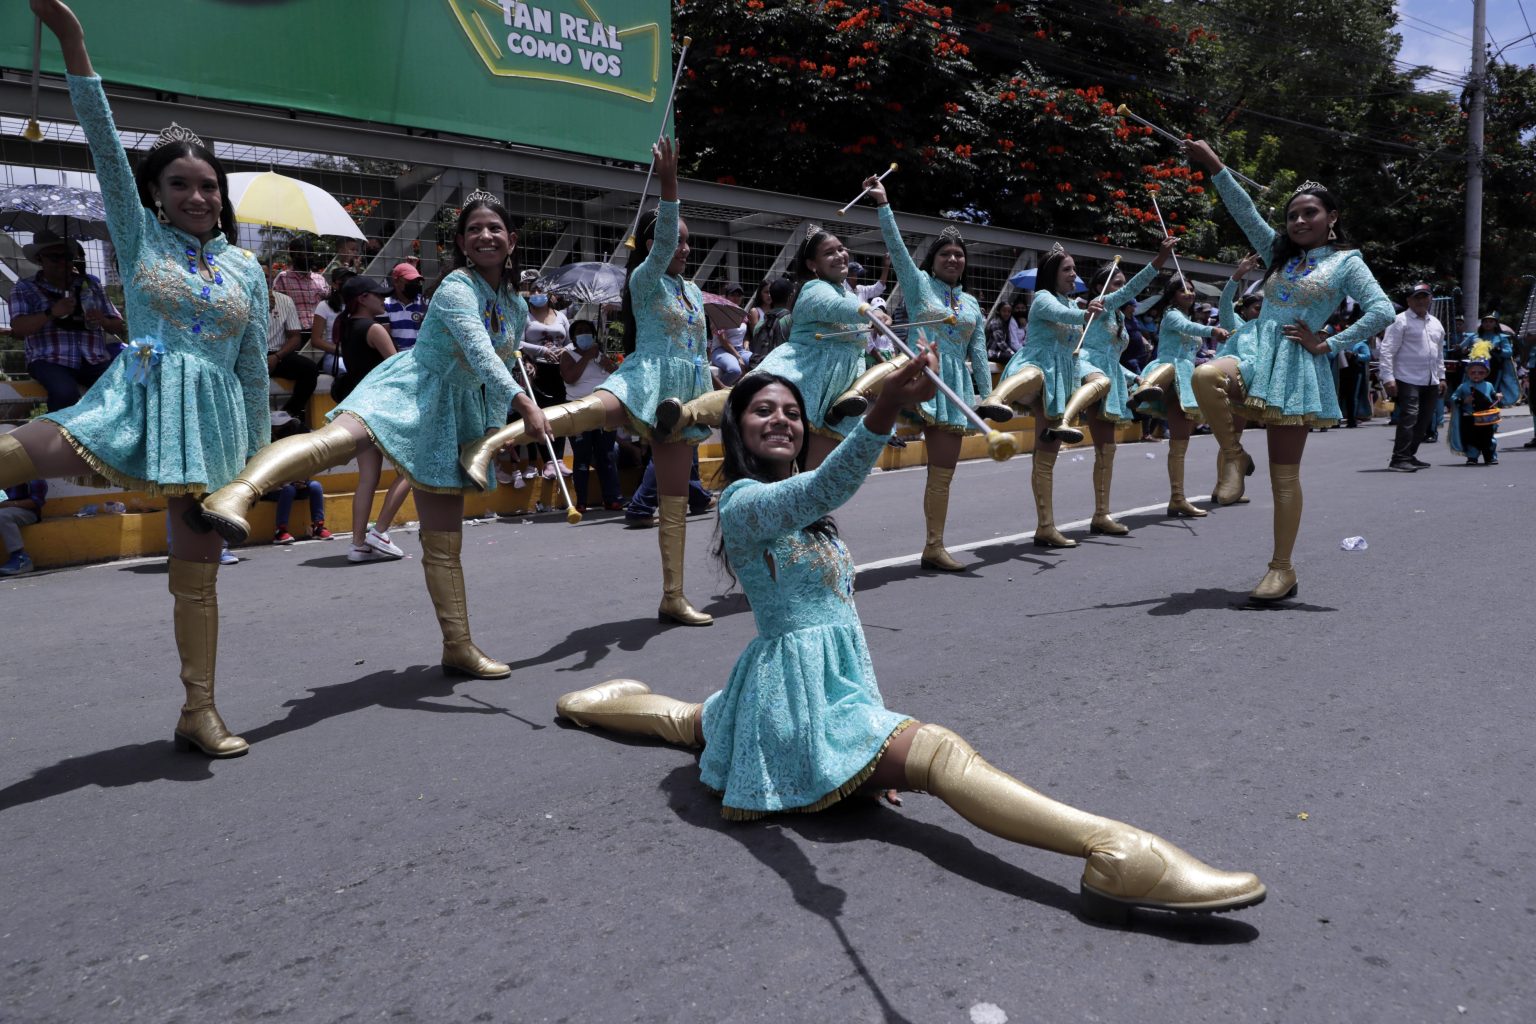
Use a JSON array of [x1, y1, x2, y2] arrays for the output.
[[554, 348, 1266, 918]]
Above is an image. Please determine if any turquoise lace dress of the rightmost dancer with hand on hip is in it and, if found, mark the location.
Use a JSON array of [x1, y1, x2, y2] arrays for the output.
[[1212, 167, 1393, 427]]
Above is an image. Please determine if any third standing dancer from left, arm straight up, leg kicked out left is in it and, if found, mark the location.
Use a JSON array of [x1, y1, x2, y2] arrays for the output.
[[461, 138, 725, 626]]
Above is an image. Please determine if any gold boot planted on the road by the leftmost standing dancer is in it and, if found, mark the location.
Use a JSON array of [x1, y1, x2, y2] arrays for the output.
[[166, 556, 250, 757]]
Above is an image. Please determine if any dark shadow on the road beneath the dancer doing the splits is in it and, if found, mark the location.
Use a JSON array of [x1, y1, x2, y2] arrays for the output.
[[659, 765, 1260, 970]]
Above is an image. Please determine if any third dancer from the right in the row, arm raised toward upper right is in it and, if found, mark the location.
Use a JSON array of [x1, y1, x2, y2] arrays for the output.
[[1063, 238, 1175, 537]]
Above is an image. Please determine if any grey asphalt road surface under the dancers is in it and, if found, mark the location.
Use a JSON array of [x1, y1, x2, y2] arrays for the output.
[[0, 418, 1536, 1024]]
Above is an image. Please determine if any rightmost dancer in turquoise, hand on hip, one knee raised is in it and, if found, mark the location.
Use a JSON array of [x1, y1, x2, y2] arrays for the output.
[[1184, 141, 1393, 602]]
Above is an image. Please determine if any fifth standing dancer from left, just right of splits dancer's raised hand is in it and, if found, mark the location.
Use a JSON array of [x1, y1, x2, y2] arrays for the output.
[[854, 177, 992, 573]]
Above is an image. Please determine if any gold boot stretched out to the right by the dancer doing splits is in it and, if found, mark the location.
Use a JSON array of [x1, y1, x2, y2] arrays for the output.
[[906, 725, 1266, 918]]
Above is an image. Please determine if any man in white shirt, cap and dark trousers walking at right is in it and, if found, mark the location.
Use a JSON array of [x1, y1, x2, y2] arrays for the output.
[[1378, 284, 1445, 473]]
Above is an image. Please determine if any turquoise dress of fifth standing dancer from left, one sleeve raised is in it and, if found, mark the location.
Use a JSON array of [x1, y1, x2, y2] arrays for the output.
[[880, 204, 992, 433]]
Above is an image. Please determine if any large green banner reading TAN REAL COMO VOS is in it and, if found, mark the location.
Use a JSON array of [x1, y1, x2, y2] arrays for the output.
[[0, 0, 671, 163]]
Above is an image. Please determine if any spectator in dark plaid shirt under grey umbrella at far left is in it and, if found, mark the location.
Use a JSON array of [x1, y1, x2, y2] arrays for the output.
[[9, 230, 126, 413]]
